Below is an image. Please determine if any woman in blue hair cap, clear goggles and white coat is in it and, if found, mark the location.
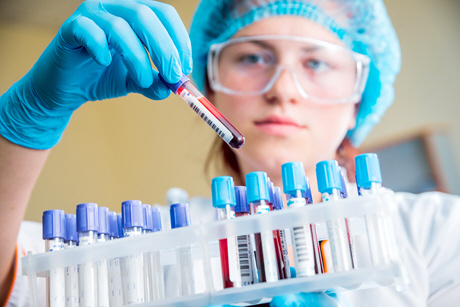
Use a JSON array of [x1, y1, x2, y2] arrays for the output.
[[0, 0, 460, 306]]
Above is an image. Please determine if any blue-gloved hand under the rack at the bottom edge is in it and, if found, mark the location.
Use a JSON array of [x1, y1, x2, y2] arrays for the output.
[[270, 292, 352, 307]]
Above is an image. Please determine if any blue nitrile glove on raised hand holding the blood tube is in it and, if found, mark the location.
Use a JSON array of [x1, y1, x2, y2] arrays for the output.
[[0, 0, 192, 149]]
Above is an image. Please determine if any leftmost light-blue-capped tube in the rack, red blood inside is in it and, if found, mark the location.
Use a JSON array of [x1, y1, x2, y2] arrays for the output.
[[211, 176, 241, 288]]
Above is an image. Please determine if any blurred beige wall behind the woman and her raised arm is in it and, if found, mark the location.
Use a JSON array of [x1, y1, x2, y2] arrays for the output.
[[0, 0, 460, 221]]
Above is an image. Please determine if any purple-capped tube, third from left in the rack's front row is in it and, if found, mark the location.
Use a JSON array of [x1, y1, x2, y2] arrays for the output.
[[120, 200, 144, 305]]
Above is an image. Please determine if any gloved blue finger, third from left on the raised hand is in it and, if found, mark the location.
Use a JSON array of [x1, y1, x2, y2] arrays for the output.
[[103, 1, 182, 83]]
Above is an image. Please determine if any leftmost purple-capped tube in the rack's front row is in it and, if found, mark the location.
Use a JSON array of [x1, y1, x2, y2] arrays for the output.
[[42, 210, 65, 307]]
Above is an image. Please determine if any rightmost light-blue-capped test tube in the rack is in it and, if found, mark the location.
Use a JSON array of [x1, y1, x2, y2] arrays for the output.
[[355, 154, 391, 265]]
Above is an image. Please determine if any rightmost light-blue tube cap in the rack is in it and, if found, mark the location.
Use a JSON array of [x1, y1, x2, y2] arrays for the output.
[[355, 153, 382, 188]]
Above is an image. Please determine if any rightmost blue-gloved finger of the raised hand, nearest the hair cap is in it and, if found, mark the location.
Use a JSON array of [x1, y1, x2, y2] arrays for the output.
[[137, 0, 193, 75]]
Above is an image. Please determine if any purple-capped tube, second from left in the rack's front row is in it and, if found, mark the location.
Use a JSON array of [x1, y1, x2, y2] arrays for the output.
[[77, 203, 99, 307]]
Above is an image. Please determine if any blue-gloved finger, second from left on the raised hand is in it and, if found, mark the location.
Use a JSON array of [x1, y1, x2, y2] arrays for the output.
[[89, 2, 153, 88]]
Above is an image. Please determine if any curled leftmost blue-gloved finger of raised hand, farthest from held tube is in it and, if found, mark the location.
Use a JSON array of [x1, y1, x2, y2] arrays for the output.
[[59, 15, 112, 66]]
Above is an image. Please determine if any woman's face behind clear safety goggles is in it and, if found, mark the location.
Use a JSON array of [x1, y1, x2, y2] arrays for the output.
[[209, 16, 356, 176]]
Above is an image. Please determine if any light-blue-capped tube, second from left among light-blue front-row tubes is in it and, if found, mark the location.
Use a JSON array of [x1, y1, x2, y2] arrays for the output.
[[246, 172, 279, 282]]
